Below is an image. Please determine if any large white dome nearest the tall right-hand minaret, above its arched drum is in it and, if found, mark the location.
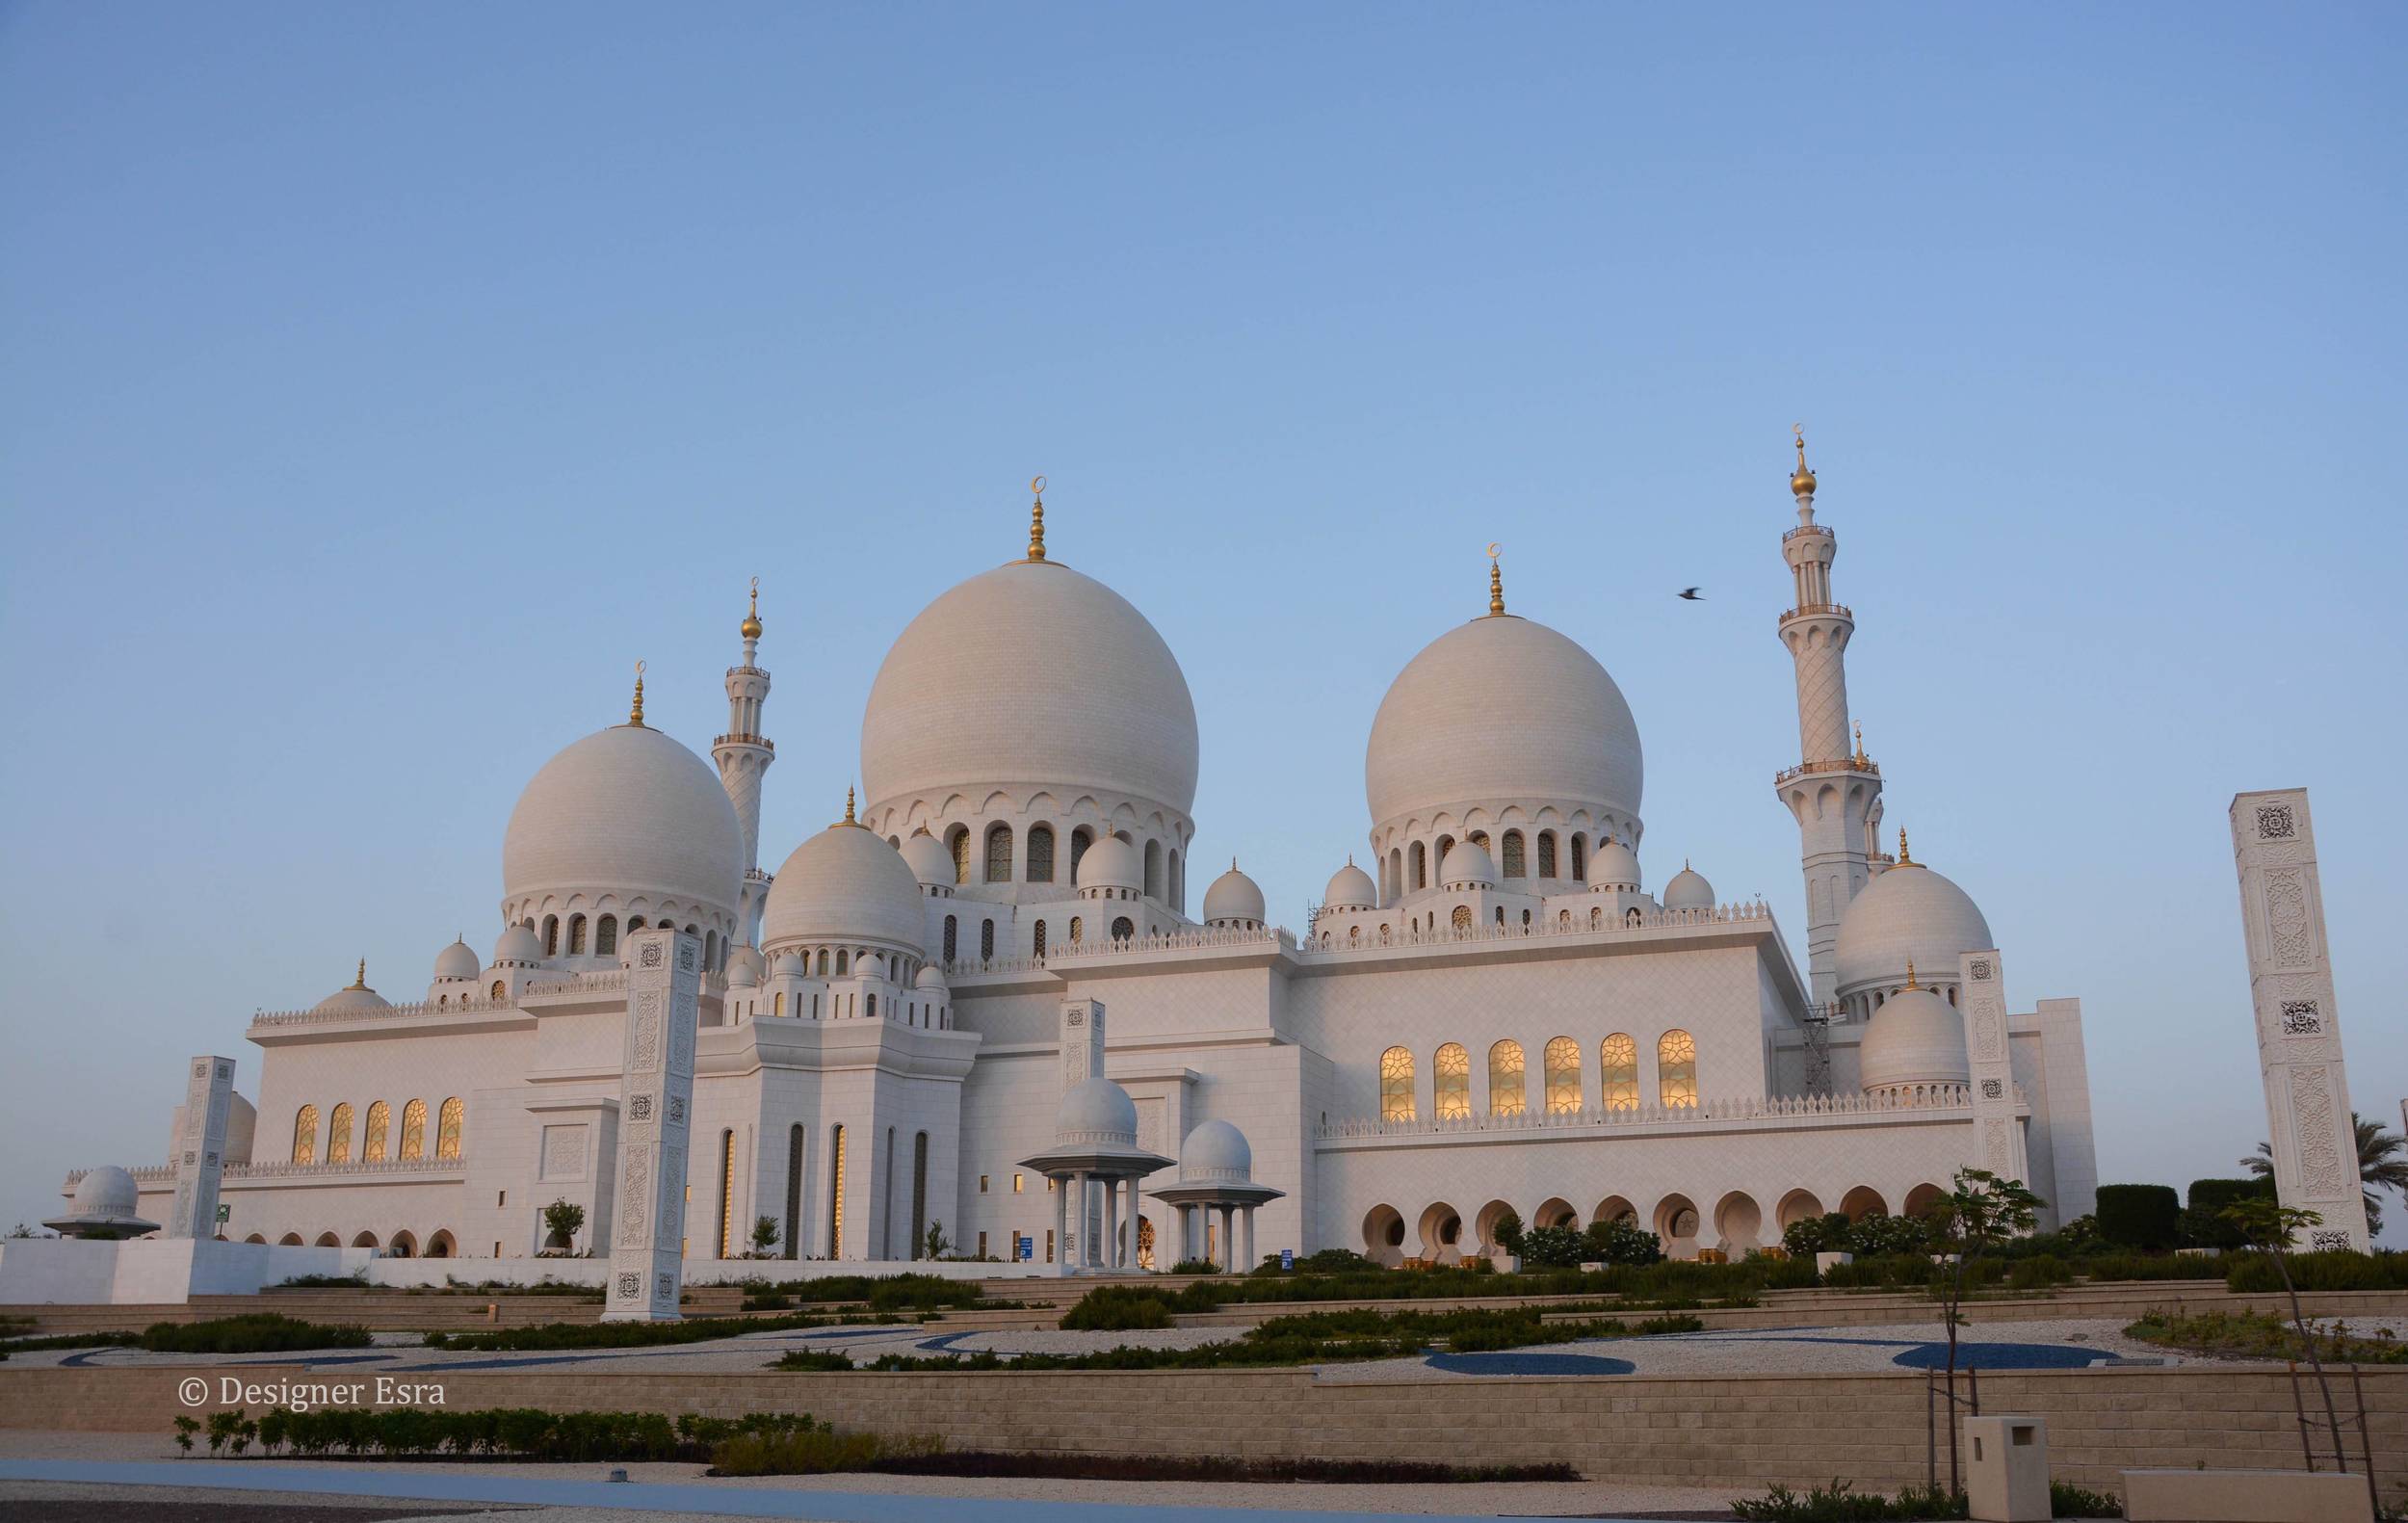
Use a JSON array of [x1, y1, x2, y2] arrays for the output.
[[1363, 615, 1642, 825]]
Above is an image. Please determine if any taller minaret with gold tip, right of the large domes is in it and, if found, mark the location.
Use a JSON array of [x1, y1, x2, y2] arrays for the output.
[[1775, 429, 1881, 1005]]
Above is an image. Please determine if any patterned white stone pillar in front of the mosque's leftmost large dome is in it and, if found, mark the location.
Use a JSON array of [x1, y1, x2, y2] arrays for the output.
[[602, 931, 703, 1323]]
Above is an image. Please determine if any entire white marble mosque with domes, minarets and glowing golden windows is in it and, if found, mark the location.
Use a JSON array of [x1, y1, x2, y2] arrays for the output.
[[61, 441, 2095, 1273]]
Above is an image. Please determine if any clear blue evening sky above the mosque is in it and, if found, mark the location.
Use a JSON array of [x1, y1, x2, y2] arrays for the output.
[[0, 0, 2408, 1241]]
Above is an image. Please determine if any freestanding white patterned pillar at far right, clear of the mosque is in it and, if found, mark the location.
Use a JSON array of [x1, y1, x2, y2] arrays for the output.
[[2233, 788, 2368, 1253]]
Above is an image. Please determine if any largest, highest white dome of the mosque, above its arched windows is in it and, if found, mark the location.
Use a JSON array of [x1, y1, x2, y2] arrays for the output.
[[862, 562, 1197, 817]]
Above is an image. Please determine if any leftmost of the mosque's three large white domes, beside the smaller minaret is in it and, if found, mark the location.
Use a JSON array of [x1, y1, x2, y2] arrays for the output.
[[501, 725, 745, 921]]
